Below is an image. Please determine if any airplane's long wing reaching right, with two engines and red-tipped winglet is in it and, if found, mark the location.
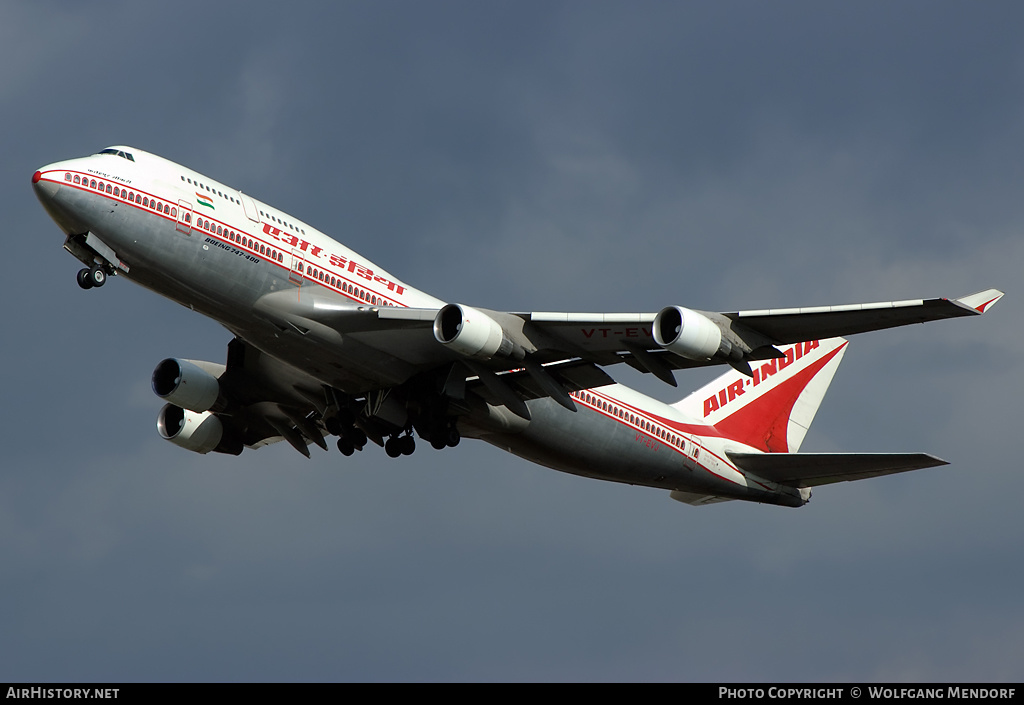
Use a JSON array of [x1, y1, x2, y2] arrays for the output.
[[255, 289, 1002, 415]]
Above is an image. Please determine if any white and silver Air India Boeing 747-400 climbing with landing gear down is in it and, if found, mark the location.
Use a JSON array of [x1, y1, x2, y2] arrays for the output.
[[32, 146, 1002, 507]]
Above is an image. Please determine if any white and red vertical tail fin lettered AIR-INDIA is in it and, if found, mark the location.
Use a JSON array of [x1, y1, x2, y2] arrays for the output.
[[673, 338, 848, 453]]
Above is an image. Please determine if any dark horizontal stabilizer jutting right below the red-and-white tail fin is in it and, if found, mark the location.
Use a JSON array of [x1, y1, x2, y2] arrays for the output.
[[727, 453, 949, 487]]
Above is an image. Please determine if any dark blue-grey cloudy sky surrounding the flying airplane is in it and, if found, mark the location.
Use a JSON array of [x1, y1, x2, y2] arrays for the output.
[[0, 0, 1024, 681]]
